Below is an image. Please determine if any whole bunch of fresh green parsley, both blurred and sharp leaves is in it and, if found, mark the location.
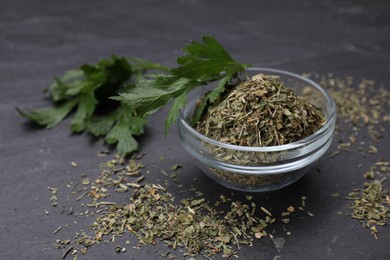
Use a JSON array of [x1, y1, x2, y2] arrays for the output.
[[17, 36, 250, 156]]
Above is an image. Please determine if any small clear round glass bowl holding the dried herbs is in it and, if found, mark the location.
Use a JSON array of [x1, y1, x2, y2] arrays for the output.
[[178, 68, 336, 192]]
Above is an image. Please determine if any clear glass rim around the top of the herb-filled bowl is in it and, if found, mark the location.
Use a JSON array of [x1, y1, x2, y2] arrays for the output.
[[179, 67, 336, 152]]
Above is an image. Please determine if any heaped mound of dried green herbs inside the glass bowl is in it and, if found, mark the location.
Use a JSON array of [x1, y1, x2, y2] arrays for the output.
[[196, 74, 325, 146]]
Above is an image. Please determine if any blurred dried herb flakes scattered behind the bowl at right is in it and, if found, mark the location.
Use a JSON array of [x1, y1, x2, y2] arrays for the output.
[[314, 74, 390, 157]]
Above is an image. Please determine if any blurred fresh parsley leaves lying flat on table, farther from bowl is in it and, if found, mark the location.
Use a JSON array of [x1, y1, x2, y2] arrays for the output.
[[16, 55, 168, 155]]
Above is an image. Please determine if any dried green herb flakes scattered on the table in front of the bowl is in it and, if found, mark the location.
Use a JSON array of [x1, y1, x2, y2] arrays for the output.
[[49, 155, 312, 259]]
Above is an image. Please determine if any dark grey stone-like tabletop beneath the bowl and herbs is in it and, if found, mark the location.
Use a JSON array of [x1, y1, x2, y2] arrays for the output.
[[0, 0, 390, 259]]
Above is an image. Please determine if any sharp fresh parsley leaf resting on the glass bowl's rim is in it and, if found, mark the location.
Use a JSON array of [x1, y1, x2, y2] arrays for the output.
[[113, 36, 250, 136]]
